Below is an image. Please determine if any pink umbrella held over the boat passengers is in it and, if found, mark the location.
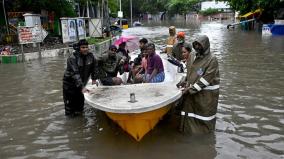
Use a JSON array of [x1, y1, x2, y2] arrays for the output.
[[114, 36, 139, 52]]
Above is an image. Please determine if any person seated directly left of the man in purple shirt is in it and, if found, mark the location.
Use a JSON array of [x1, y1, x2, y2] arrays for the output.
[[127, 38, 148, 83]]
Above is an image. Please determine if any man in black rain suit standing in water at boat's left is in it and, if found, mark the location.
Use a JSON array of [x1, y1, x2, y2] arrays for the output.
[[63, 39, 98, 116]]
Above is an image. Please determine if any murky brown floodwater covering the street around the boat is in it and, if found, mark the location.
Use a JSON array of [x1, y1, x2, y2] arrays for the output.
[[0, 22, 284, 159]]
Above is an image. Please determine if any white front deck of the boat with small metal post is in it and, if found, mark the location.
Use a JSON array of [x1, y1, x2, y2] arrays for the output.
[[85, 83, 181, 113]]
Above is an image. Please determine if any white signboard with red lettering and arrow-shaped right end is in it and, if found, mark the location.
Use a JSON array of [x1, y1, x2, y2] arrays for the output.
[[18, 26, 47, 44]]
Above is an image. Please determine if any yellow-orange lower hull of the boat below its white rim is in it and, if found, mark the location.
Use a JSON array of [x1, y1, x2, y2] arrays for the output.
[[106, 104, 172, 141]]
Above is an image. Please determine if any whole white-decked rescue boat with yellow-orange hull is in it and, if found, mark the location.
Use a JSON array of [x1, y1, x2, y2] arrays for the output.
[[84, 54, 185, 141]]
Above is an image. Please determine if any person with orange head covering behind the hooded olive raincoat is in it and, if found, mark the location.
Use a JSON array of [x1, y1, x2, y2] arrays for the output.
[[172, 32, 190, 61]]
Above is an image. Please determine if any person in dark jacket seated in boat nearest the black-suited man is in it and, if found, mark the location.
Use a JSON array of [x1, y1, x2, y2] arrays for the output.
[[98, 45, 125, 86]]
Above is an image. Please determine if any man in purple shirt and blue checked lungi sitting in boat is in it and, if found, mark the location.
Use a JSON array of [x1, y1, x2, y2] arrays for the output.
[[144, 43, 165, 83]]
